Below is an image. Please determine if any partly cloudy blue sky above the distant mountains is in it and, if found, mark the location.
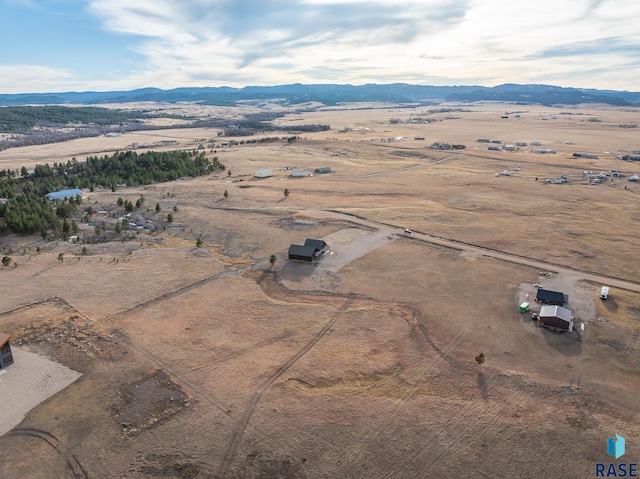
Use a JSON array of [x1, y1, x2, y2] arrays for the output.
[[0, 0, 640, 93]]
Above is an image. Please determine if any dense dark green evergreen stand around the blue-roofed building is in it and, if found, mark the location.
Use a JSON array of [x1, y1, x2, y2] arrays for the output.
[[0, 151, 225, 237]]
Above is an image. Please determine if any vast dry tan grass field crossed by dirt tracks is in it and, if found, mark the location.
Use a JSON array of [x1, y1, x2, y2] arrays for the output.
[[0, 104, 640, 479]]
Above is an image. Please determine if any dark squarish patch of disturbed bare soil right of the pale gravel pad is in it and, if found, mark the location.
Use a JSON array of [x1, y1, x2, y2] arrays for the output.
[[112, 370, 192, 437]]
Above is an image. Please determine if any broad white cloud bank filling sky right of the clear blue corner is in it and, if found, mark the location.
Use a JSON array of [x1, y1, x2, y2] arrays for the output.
[[12, 0, 640, 90]]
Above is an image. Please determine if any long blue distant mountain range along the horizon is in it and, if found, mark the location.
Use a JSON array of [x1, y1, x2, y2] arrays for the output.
[[0, 83, 640, 106]]
